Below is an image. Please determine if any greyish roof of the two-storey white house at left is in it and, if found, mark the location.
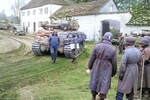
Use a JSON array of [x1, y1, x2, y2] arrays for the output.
[[21, 0, 76, 10]]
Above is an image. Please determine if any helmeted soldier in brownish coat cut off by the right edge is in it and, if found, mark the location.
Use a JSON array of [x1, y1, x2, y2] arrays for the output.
[[139, 36, 150, 97]]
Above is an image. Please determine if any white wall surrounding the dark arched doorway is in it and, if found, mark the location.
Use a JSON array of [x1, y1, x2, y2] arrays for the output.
[[74, 13, 131, 42]]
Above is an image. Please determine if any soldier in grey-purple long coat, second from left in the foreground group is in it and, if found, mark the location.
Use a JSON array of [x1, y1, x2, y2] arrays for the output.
[[116, 36, 141, 100]]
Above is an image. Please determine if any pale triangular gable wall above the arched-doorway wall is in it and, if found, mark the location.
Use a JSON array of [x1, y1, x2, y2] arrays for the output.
[[100, 0, 118, 13]]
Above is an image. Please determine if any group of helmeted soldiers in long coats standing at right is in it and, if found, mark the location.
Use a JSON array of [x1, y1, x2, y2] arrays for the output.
[[88, 32, 150, 100]]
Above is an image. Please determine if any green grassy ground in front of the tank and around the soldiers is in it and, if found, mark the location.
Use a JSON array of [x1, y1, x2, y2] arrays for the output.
[[0, 42, 121, 100]]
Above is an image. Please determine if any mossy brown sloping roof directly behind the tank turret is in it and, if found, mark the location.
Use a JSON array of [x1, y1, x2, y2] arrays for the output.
[[51, 0, 110, 18]]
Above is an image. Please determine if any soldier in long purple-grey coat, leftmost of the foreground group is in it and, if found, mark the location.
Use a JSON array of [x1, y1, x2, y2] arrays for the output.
[[88, 32, 117, 100]]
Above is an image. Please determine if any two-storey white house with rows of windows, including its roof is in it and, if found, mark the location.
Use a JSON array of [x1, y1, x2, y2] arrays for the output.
[[21, 0, 75, 33]]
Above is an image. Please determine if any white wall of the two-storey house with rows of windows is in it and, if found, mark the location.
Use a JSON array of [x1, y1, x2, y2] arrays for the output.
[[21, 4, 62, 33]]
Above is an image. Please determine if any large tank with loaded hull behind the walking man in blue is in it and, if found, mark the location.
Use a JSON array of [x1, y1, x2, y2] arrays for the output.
[[32, 19, 86, 59]]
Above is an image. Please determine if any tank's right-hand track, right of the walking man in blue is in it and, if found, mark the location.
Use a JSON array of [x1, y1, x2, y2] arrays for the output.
[[64, 44, 84, 59]]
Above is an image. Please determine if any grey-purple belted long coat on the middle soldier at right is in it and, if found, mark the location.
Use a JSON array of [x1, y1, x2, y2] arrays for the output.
[[117, 46, 141, 94]]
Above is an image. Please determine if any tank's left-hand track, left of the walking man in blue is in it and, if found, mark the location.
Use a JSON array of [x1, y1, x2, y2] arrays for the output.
[[32, 42, 42, 56]]
